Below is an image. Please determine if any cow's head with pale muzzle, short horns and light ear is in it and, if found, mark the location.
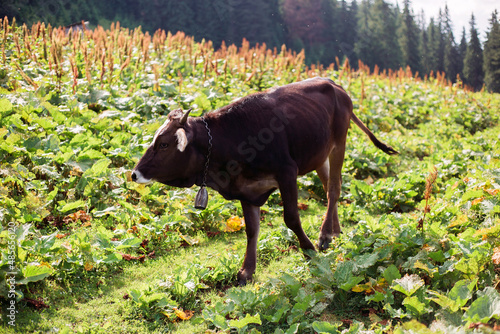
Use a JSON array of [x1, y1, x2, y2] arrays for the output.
[[132, 109, 204, 187]]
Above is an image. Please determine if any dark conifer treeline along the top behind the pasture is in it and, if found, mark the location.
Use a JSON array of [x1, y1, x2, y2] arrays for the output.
[[0, 0, 500, 92]]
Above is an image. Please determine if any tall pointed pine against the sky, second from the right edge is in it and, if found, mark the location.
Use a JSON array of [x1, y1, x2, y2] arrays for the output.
[[464, 14, 484, 90]]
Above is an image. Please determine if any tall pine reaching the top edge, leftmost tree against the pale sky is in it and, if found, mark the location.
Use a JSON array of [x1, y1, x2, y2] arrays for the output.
[[399, 0, 421, 72]]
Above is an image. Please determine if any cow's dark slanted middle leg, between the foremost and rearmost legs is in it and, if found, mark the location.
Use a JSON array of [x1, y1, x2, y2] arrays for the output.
[[278, 170, 315, 250]]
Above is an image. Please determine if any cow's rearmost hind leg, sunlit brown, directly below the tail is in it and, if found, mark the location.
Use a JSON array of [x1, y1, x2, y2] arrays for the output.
[[318, 139, 345, 250]]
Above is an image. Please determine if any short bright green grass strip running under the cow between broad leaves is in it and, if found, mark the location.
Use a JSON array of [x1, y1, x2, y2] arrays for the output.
[[4, 200, 333, 334]]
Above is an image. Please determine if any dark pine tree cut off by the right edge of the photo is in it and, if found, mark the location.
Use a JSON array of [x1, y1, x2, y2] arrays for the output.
[[484, 10, 500, 93]]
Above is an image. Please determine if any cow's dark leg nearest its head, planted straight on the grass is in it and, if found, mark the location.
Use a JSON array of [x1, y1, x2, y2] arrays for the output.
[[237, 201, 260, 285]]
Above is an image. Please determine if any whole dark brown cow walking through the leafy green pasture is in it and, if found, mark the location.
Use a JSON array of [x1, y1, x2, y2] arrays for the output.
[[132, 78, 397, 284]]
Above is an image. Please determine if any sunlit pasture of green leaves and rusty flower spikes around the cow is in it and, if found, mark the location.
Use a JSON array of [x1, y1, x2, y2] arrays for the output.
[[0, 20, 500, 334]]
